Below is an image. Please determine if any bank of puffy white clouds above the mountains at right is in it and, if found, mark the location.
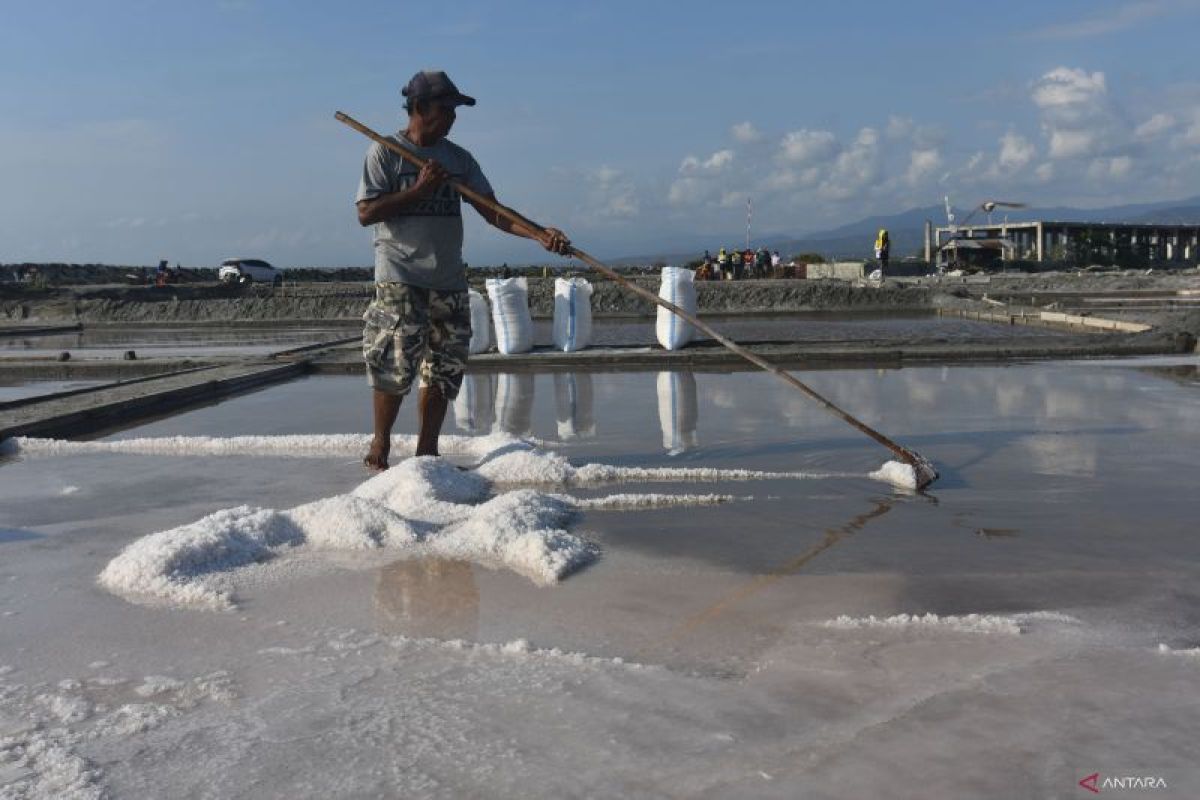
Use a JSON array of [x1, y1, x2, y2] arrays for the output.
[[657, 66, 1200, 237]]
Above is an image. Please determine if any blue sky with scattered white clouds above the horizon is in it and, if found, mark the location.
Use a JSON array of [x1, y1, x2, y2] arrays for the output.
[[0, 0, 1200, 266]]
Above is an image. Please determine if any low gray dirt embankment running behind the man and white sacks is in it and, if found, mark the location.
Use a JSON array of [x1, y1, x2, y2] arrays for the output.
[[0, 277, 935, 324]]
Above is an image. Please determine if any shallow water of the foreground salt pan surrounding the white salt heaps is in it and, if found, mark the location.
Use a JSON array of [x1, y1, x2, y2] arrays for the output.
[[0, 357, 1200, 798]]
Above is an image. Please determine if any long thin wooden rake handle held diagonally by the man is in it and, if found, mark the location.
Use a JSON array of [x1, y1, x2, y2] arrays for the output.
[[334, 112, 937, 488]]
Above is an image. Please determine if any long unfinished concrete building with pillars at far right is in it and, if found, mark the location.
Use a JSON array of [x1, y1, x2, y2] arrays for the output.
[[925, 221, 1200, 267]]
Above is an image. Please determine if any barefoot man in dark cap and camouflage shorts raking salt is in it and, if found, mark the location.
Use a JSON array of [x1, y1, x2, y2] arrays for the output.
[[355, 71, 570, 470]]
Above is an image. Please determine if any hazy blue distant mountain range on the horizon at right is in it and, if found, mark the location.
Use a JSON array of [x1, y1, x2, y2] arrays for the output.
[[610, 196, 1200, 264]]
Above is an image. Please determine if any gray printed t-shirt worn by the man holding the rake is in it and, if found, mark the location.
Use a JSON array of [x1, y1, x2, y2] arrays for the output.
[[354, 132, 492, 291]]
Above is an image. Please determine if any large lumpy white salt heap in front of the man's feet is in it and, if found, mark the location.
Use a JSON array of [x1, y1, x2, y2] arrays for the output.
[[100, 456, 598, 608]]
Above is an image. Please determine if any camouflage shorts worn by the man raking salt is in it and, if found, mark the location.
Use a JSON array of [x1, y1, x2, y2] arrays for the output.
[[362, 283, 470, 399]]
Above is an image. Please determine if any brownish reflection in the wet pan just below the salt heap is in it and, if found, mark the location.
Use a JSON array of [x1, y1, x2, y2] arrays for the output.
[[374, 559, 479, 639]]
